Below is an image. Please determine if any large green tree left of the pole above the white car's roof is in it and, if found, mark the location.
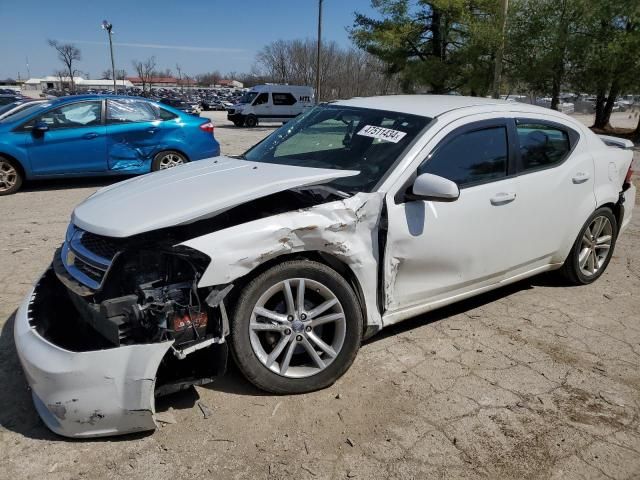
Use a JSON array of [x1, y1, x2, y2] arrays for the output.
[[350, 0, 500, 95]]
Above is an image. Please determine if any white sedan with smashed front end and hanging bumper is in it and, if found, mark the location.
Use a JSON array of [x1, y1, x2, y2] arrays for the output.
[[15, 96, 635, 437]]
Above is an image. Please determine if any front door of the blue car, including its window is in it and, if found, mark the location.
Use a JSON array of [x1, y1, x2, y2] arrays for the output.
[[22, 100, 107, 175]]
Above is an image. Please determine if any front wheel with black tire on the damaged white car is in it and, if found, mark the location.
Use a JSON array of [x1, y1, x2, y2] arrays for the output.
[[231, 260, 363, 394]]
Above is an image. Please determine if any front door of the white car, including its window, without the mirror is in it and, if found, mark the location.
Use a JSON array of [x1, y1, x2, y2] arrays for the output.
[[384, 119, 522, 314]]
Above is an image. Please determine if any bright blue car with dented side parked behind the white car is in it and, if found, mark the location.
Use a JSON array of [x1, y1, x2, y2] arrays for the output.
[[0, 95, 220, 195]]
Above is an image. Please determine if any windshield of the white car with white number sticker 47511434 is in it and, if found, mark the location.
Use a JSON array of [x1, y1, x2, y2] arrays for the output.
[[241, 105, 431, 193]]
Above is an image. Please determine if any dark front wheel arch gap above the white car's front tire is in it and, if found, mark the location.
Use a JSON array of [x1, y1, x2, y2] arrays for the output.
[[229, 250, 370, 338]]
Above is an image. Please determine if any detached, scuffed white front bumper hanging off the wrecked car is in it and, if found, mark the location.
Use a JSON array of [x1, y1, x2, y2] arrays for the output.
[[14, 269, 173, 437]]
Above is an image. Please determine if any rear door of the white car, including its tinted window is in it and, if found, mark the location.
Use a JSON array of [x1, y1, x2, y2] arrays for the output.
[[508, 115, 595, 273]]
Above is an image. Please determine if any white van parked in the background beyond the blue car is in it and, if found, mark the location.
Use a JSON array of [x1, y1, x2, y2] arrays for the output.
[[227, 85, 315, 127]]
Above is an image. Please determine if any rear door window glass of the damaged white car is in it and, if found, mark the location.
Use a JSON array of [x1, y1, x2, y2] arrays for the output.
[[517, 121, 571, 172]]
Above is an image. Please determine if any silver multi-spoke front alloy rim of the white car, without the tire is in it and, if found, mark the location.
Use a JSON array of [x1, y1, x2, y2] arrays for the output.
[[249, 278, 346, 378]]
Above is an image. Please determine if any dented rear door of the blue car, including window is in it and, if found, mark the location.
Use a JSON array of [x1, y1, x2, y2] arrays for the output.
[[107, 98, 167, 170]]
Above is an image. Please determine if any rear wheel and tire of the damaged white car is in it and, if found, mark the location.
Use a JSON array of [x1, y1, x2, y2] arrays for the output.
[[560, 207, 618, 285]]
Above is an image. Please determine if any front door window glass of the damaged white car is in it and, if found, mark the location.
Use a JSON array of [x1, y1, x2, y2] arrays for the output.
[[418, 127, 508, 187]]
